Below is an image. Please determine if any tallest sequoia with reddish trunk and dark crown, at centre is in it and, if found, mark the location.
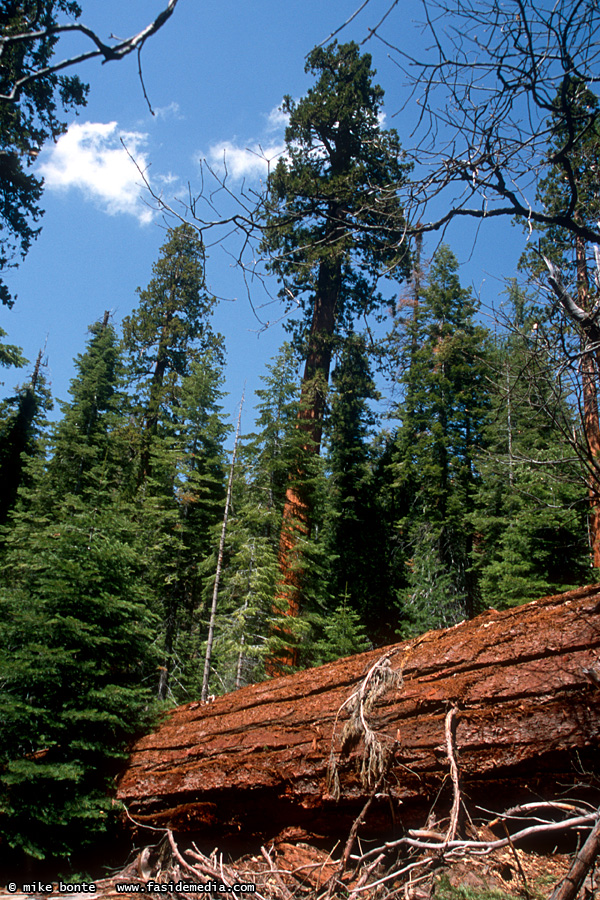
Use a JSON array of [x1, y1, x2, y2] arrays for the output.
[[263, 42, 409, 644]]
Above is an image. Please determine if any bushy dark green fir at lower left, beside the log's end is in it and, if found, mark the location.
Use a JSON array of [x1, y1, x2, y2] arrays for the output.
[[0, 501, 155, 861]]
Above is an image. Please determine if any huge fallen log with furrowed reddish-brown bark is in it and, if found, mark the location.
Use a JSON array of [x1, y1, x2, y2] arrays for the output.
[[118, 585, 600, 842]]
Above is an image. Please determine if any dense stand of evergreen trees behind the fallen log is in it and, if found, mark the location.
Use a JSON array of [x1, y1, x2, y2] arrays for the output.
[[0, 19, 600, 880]]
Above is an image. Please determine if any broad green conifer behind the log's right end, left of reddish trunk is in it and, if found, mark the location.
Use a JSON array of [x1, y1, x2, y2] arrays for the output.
[[472, 283, 589, 607]]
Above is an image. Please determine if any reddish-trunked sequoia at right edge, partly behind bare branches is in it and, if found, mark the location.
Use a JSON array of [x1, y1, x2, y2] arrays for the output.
[[521, 82, 600, 567]]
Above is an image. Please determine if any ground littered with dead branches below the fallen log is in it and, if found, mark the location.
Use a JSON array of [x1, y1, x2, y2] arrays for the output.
[[0, 833, 600, 900]]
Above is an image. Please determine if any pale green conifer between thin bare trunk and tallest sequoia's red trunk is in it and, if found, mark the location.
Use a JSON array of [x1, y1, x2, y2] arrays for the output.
[[206, 344, 327, 690]]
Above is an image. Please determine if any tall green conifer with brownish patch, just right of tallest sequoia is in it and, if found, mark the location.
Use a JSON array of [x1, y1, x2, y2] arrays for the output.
[[393, 245, 488, 627]]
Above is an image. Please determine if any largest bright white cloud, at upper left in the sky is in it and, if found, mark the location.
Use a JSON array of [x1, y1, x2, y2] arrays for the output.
[[40, 122, 153, 224]]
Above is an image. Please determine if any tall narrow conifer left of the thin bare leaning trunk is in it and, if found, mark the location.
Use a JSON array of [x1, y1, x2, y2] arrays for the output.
[[123, 225, 228, 700]]
